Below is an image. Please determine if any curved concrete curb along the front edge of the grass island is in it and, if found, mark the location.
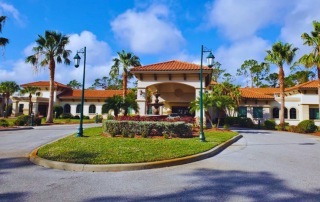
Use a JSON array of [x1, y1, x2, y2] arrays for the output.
[[29, 135, 242, 172]]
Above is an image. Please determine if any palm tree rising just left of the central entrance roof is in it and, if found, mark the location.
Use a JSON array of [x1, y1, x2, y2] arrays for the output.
[[110, 50, 141, 97]]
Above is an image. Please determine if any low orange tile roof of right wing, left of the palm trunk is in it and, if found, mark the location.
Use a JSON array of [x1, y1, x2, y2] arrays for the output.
[[240, 88, 280, 99]]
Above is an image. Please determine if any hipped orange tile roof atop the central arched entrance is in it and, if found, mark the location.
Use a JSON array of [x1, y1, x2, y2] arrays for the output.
[[130, 60, 212, 72]]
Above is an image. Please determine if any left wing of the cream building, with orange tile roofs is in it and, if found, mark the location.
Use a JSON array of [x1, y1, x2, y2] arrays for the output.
[[11, 81, 122, 118]]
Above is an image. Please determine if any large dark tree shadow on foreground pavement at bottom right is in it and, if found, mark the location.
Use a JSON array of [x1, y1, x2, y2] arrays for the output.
[[87, 169, 320, 202]]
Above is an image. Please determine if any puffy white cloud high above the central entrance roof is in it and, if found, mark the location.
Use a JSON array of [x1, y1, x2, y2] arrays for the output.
[[111, 5, 185, 54]]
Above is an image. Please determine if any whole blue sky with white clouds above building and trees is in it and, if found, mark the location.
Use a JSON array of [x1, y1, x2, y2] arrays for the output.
[[0, 0, 320, 87]]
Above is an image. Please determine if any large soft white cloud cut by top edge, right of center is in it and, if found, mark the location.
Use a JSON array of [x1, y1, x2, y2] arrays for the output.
[[207, 0, 285, 40]]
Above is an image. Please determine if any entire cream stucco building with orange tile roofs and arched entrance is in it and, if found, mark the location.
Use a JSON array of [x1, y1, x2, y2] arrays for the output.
[[4, 60, 320, 125]]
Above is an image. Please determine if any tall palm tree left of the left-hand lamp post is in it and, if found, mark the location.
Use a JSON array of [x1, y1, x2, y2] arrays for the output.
[[25, 31, 71, 123]]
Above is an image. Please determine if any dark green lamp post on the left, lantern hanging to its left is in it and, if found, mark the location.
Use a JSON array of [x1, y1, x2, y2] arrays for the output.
[[73, 47, 86, 137]]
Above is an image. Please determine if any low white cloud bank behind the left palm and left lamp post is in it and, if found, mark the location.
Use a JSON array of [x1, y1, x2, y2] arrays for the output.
[[0, 31, 112, 87]]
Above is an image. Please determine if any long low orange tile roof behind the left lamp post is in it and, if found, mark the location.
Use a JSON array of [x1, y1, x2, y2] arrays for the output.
[[58, 90, 124, 99]]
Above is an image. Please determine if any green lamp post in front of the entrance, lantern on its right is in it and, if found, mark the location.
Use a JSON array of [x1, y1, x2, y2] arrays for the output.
[[199, 45, 214, 142]]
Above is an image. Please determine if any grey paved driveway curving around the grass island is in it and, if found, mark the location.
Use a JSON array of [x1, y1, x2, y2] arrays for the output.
[[0, 126, 320, 202]]
